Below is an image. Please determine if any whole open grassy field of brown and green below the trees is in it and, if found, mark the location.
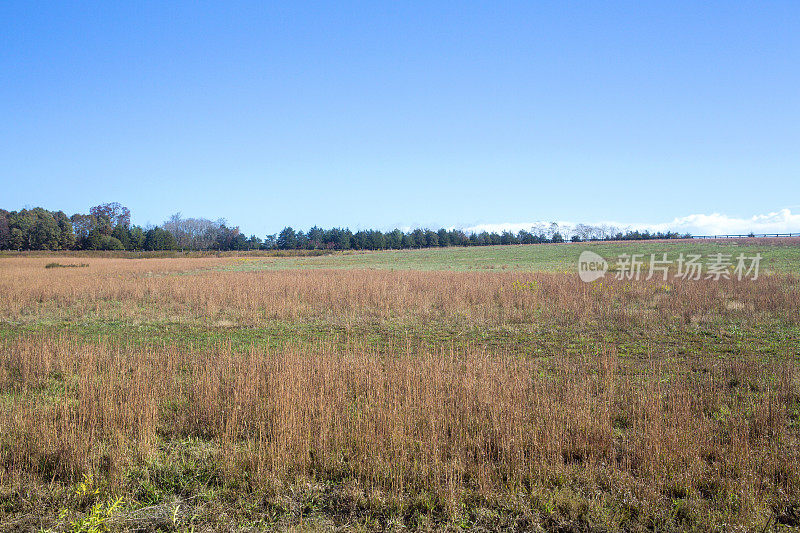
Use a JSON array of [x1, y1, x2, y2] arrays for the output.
[[0, 240, 800, 531]]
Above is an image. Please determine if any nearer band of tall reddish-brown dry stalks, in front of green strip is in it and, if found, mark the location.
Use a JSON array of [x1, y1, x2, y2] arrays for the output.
[[0, 335, 800, 512]]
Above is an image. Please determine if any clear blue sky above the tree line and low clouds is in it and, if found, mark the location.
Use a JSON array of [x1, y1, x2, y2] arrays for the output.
[[0, 1, 800, 235]]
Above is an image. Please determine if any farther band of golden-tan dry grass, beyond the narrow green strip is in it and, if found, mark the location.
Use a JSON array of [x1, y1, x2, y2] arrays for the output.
[[0, 254, 800, 326]]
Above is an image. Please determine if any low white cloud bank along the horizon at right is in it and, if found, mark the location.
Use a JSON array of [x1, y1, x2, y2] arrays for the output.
[[462, 208, 800, 236]]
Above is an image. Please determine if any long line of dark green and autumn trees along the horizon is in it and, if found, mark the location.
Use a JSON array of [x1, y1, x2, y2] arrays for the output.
[[0, 202, 691, 251]]
